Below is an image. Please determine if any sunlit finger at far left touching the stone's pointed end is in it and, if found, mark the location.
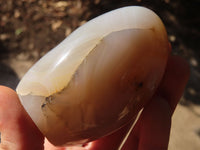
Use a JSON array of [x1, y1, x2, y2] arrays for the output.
[[0, 86, 44, 150]]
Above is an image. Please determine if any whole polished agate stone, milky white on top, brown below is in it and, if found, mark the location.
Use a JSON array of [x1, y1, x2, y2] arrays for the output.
[[16, 7, 169, 145]]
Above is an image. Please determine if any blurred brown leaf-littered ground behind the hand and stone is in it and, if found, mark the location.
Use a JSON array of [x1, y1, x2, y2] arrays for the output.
[[0, 0, 200, 150]]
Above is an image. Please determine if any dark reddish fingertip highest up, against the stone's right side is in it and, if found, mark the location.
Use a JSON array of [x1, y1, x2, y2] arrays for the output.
[[158, 56, 190, 113]]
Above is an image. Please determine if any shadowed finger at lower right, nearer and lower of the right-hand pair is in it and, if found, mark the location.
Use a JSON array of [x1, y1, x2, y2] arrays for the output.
[[123, 96, 171, 150]]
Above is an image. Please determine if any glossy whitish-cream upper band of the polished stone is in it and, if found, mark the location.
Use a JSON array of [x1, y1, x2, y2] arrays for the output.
[[16, 6, 167, 96]]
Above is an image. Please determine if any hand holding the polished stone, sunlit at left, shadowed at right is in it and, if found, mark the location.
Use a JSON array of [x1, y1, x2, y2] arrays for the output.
[[0, 56, 189, 150]]
